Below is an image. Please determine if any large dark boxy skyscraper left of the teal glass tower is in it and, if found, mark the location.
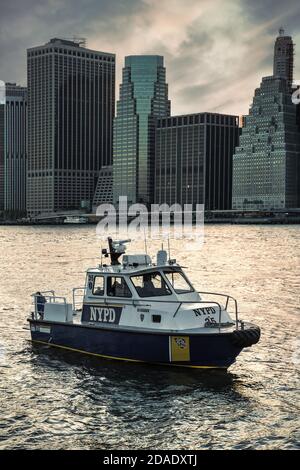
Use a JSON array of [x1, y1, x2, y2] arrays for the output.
[[27, 38, 115, 215]]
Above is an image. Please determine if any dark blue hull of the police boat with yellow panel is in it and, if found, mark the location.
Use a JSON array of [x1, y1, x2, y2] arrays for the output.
[[29, 319, 260, 368]]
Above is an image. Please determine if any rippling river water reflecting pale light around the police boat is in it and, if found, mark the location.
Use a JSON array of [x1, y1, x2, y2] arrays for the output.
[[0, 225, 300, 449]]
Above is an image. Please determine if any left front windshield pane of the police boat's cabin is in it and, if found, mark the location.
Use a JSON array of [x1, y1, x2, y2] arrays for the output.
[[131, 272, 171, 297]]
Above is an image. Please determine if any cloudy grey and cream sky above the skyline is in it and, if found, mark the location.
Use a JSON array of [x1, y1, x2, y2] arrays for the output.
[[0, 0, 300, 115]]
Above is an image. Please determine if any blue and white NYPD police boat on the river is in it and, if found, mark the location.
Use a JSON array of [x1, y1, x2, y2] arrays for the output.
[[28, 238, 260, 369]]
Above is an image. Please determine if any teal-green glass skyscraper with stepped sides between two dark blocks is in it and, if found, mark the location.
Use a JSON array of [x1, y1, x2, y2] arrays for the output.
[[113, 55, 170, 204]]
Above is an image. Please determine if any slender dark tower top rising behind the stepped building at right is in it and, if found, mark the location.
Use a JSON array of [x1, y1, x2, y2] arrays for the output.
[[273, 28, 294, 86]]
